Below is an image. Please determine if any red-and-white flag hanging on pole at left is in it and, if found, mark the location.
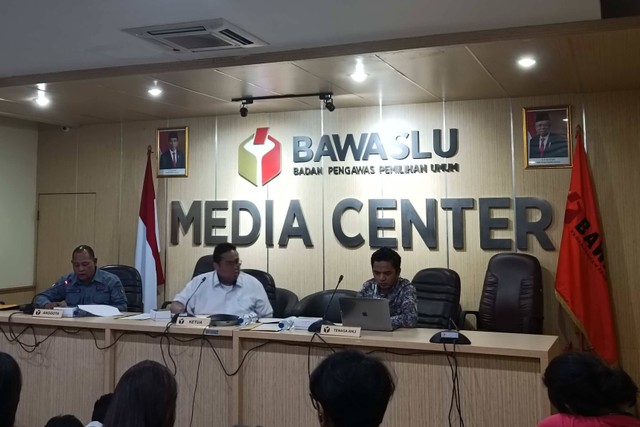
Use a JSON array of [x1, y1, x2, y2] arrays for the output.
[[135, 147, 164, 313]]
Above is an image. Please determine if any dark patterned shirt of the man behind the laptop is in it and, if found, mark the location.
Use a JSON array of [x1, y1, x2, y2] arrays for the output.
[[358, 277, 418, 329]]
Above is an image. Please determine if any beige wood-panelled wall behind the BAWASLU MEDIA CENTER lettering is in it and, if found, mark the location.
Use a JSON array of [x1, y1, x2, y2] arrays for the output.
[[38, 92, 640, 379]]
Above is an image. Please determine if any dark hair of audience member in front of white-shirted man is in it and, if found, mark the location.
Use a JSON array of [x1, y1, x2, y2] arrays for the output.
[[103, 360, 178, 427]]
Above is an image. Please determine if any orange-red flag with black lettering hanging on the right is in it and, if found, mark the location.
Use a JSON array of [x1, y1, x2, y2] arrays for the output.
[[555, 126, 618, 364]]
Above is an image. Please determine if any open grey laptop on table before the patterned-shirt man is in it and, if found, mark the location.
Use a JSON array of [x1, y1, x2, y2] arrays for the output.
[[339, 298, 393, 331]]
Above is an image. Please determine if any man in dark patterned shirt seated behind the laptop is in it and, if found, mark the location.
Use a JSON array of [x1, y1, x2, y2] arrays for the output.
[[358, 248, 418, 329]]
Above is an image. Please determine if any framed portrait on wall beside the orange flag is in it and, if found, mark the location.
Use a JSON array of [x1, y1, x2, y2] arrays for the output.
[[522, 105, 572, 168]]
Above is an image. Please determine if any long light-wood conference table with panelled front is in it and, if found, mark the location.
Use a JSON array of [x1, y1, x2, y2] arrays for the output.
[[0, 312, 560, 427]]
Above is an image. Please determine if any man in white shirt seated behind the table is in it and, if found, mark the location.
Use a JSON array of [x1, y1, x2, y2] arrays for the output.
[[171, 243, 273, 317]]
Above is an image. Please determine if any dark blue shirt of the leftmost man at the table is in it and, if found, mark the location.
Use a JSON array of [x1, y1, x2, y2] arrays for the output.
[[33, 269, 127, 311]]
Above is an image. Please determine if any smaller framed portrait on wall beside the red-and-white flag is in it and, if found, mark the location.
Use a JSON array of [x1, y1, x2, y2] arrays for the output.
[[156, 126, 189, 178]]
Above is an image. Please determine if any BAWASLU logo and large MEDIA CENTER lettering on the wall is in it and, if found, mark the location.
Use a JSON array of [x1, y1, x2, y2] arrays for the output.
[[171, 127, 555, 250]]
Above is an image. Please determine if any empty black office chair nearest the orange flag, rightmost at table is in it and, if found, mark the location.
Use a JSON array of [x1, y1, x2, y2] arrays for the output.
[[461, 253, 544, 334]]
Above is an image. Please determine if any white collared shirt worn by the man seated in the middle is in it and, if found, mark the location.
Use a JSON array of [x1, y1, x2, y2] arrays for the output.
[[173, 271, 273, 317]]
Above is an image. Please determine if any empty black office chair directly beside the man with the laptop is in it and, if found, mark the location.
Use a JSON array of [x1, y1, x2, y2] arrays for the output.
[[412, 268, 460, 329]]
